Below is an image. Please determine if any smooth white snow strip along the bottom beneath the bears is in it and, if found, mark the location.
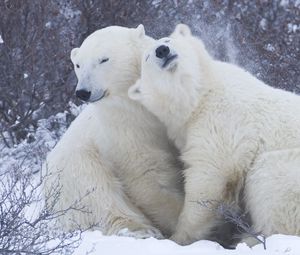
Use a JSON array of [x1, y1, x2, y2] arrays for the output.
[[74, 231, 300, 255]]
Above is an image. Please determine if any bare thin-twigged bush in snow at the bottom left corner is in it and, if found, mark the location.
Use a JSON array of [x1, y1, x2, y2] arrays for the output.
[[0, 164, 83, 255]]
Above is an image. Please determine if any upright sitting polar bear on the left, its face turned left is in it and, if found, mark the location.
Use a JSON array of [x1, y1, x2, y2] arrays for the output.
[[44, 25, 184, 237]]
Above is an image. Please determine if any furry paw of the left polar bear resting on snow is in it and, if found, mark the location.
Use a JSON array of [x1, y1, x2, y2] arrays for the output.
[[117, 227, 163, 239]]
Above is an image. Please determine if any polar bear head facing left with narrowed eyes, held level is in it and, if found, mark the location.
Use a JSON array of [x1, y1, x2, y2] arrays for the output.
[[71, 25, 153, 102]]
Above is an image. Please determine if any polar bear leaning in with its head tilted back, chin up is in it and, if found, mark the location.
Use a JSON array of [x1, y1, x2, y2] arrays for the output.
[[129, 25, 300, 244]]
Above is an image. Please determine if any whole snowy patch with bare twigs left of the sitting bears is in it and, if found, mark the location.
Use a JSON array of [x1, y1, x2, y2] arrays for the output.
[[0, 104, 84, 254]]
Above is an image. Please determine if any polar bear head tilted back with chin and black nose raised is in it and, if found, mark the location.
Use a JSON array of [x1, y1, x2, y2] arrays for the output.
[[128, 25, 212, 125]]
